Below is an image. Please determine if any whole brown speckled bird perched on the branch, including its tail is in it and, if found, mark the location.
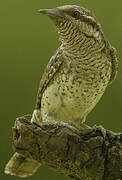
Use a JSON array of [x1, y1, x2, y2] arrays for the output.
[[5, 5, 118, 177]]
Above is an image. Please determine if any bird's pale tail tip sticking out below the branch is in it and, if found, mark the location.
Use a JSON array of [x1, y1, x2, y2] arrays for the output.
[[5, 153, 41, 177]]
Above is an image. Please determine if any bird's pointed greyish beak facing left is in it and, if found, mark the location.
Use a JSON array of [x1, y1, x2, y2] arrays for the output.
[[38, 9, 64, 18]]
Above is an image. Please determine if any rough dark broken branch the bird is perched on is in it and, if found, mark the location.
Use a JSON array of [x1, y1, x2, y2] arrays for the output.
[[4, 118, 122, 180]]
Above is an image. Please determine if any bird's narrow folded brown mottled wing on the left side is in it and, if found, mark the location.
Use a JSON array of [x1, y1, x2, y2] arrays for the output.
[[36, 48, 63, 109]]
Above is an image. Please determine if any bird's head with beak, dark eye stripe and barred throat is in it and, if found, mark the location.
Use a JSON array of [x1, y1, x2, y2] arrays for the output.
[[39, 5, 103, 45]]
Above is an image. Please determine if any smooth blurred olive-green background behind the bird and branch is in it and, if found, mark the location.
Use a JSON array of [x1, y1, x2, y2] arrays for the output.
[[0, 0, 122, 180]]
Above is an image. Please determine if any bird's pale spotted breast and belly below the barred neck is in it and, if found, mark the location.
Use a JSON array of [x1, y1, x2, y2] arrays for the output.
[[41, 52, 110, 122]]
